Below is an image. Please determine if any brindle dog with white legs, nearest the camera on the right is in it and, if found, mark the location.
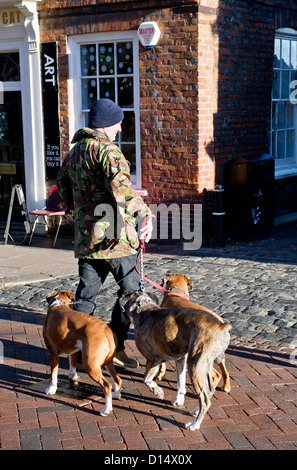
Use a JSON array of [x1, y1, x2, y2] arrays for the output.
[[121, 291, 231, 431]]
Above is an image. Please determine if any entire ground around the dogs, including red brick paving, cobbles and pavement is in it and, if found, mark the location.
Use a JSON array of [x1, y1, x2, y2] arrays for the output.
[[0, 230, 297, 453]]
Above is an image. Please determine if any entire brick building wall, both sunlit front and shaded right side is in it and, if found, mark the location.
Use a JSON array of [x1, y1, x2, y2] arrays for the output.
[[40, 0, 297, 246]]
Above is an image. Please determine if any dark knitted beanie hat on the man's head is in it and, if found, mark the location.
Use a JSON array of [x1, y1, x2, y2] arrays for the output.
[[89, 98, 124, 129]]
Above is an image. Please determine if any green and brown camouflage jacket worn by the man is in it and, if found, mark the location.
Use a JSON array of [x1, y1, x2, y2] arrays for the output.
[[57, 128, 151, 259]]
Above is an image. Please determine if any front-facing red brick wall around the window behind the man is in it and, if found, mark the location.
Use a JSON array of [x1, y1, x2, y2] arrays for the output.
[[40, 1, 198, 207]]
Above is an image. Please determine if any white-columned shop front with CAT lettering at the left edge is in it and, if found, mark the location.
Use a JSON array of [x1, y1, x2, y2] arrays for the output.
[[0, 0, 45, 226]]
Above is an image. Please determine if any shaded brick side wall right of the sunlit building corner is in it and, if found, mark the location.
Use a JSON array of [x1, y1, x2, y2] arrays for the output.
[[213, 0, 297, 227]]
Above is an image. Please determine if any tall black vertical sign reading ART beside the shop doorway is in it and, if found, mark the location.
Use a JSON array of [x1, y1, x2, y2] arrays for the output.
[[41, 42, 61, 180]]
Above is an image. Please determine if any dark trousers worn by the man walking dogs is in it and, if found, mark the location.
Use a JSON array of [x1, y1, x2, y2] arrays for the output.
[[75, 255, 140, 351]]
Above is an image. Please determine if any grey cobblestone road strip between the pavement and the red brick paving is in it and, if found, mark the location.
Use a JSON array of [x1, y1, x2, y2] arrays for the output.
[[0, 233, 297, 343]]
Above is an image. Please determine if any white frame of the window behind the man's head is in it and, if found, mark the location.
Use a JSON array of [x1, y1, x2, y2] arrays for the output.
[[68, 31, 141, 190]]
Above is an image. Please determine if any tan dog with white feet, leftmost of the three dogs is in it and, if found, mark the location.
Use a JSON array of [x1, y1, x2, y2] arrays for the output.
[[43, 291, 122, 416]]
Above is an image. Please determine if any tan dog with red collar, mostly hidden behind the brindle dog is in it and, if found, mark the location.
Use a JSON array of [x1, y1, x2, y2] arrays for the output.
[[161, 274, 231, 392]]
